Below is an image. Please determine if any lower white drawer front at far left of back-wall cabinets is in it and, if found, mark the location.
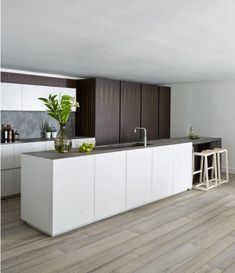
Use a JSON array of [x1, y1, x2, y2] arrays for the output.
[[1, 169, 15, 197]]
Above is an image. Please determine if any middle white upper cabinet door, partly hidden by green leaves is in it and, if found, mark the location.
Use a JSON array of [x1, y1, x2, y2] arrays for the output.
[[22, 84, 60, 111]]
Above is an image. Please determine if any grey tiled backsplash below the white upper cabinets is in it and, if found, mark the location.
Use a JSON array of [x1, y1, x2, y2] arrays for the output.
[[1, 111, 75, 138]]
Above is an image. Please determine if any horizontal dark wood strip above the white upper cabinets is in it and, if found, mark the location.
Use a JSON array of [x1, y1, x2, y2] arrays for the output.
[[1, 72, 77, 88]]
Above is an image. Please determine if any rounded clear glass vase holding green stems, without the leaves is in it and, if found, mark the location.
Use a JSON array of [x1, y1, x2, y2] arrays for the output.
[[54, 125, 72, 153]]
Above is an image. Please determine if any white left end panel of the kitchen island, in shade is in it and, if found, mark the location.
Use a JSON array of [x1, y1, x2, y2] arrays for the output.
[[21, 154, 53, 235]]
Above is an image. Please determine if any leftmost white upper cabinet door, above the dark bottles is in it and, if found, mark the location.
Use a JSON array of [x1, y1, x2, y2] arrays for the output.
[[1, 83, 22, 111]]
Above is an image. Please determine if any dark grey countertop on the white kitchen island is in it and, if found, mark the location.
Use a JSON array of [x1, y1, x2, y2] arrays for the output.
[[23, 137, 221, 160]]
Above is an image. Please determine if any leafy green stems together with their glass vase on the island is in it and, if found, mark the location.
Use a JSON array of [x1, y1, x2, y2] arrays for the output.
[[38, 94, 79, 153]]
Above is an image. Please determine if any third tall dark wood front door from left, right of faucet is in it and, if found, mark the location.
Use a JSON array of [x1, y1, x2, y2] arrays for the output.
[[141, 84, 159, 140]]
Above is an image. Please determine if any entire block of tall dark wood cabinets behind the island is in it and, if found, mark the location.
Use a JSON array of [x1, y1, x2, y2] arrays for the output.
[[76, 78, 170, 145]]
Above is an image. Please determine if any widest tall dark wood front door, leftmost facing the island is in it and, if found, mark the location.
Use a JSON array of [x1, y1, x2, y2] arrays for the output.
[[95, 79, 120, 145]]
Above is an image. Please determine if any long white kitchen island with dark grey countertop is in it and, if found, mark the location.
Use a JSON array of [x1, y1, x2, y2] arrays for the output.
[[21, 138, 220, 236]]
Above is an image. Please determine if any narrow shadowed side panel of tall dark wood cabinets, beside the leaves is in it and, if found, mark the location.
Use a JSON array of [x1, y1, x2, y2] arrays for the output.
[[75, 79, 95, 137]]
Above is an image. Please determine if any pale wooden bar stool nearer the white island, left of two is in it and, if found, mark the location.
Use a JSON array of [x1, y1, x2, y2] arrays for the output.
[[193, 150, 218, 191]]
